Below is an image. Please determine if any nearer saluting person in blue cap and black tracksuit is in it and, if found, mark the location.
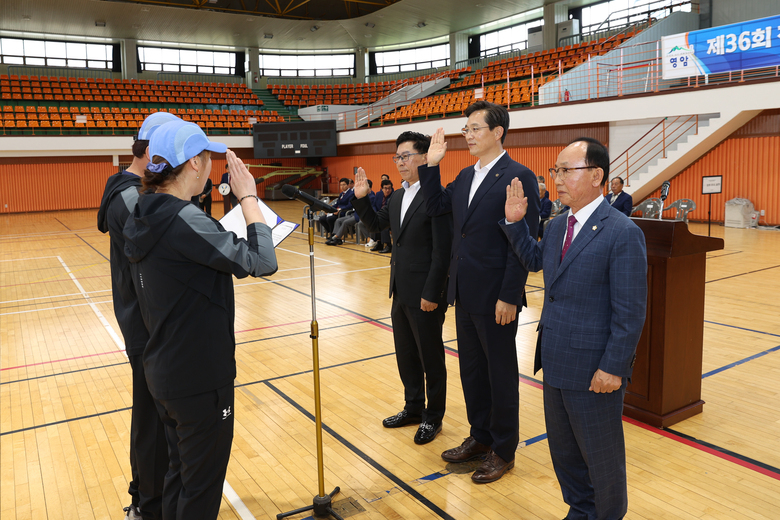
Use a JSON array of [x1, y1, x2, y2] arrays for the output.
[[124, 121, 277, 519]]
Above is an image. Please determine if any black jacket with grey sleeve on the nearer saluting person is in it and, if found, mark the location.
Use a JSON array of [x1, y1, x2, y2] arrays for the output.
[[124, 193, 277, 399]]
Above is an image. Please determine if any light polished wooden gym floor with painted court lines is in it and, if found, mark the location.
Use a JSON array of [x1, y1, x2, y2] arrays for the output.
[[0, 201, 780, 520]]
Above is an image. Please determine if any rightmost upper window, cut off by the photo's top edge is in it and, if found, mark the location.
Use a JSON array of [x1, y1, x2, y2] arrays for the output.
[[582, 0, 691, 34]]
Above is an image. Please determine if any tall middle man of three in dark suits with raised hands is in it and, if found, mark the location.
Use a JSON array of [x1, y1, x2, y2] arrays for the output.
[[418, 101, 539, 483]]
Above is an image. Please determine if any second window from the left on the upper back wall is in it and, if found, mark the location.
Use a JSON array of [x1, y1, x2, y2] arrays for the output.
[[138, 47, 236, 76]]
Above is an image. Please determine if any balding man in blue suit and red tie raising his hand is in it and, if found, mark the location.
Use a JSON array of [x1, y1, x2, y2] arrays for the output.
[[502, 138, 647, 520]]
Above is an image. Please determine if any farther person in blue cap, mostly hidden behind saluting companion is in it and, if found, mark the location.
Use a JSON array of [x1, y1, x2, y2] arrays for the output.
[[98, 112, 181, 520]]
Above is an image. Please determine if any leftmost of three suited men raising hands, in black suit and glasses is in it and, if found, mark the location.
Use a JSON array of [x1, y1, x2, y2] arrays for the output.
[[352, 132, 452, 444]]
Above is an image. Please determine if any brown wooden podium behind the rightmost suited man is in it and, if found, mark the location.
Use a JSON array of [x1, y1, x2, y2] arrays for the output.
[[623, 218, 723, 428]]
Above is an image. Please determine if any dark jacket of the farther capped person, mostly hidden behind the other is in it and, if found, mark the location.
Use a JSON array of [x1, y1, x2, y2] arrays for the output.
[[98, 171, 149, 356]]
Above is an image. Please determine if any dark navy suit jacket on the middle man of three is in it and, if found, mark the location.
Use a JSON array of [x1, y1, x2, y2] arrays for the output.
[[417, 154, 539, 315]]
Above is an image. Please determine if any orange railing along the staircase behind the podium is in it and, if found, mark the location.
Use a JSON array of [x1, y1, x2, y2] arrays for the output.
[[609, 114, 699, 186]]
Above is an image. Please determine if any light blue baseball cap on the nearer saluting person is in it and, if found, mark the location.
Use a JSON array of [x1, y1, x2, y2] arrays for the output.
[[149, 117, 227, 168]]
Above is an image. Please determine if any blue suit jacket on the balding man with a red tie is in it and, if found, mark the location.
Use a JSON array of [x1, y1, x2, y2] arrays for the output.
[[501, 200, 647, 391]]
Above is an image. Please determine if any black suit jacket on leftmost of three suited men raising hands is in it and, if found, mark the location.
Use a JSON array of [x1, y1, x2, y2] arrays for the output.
[[352, 189, 452, 308]]
